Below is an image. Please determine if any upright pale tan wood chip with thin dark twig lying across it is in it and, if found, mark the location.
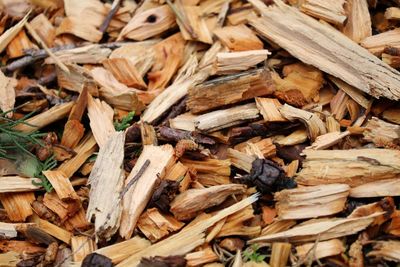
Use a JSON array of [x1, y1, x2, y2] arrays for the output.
[[119, 144, 175, 239]]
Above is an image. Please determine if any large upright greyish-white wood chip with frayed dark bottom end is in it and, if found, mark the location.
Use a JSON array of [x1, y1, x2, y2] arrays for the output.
[[86, 131, 125, 240]]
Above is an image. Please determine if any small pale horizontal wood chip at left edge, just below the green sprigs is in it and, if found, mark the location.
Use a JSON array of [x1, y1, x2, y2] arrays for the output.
[[0, 176, 40, 193]]
